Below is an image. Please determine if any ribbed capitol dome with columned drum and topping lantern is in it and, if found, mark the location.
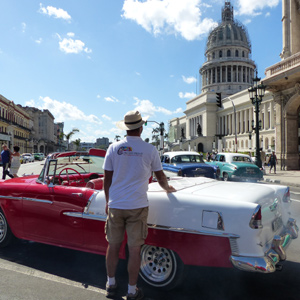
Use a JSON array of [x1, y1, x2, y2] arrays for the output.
[[199, 1, 256, 98]]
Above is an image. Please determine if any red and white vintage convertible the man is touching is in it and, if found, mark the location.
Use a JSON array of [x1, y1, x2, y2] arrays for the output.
[[0, 149, 298, 289]]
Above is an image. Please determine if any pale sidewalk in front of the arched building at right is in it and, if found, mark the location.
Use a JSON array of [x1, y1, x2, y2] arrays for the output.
[[264, 167, 300, 187]]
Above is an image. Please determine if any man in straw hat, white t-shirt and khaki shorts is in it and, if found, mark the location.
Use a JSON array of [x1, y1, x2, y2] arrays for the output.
[[103, 111, 176, 300]]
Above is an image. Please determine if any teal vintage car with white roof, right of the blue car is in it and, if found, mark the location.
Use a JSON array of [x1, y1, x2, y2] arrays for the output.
[[208, 153, 263, 182]]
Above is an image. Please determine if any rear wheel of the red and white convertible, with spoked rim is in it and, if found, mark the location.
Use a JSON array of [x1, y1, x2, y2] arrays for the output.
[[140, 245, 184, 290]]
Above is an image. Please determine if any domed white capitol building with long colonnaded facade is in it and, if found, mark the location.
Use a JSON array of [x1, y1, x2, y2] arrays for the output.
[[169, 2, 275, 161]]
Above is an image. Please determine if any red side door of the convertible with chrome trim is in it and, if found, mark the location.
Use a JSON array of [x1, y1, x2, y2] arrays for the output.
[[23, 183, 86, 247]]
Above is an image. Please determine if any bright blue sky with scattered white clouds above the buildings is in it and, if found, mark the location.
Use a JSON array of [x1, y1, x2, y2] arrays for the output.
[[0, 0, 282, 142]]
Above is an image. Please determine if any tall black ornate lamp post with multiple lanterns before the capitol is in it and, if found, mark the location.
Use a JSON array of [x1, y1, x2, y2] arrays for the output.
[[248, 70, 266, 168]]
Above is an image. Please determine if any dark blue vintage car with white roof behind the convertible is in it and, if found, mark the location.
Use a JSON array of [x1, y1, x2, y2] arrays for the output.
[[161, 151, 218, 179]]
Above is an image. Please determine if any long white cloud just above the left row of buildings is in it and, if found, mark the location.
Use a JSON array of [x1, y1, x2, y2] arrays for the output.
[[25, 97, 102, 125]]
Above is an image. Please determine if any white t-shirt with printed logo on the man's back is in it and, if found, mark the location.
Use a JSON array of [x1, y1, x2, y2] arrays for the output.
[[103, 136, 162, 209]]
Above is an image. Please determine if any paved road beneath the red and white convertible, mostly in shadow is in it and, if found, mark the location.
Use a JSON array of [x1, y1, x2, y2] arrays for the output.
[[0, 162, 300, 300]]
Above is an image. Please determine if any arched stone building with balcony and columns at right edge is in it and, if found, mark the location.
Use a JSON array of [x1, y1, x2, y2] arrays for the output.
[[263, 0, 300, 170]]
